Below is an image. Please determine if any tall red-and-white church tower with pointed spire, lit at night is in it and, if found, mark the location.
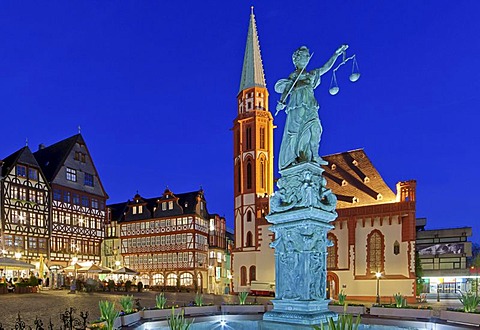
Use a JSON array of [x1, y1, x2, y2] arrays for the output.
[[232, 7, 275, 292]]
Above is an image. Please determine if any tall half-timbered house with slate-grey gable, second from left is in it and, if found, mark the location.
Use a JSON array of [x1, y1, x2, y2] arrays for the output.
[[34, 134, 108, 266]]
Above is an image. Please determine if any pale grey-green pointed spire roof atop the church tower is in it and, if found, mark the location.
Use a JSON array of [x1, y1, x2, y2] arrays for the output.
[[239, 6, 267, 92]]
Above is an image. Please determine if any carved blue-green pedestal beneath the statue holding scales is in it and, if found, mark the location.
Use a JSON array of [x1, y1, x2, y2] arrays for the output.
[[263, 160, 337, 325]]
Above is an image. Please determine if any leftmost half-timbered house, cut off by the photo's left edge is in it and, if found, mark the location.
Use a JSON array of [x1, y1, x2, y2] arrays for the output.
[[0, 146, 51, 263]]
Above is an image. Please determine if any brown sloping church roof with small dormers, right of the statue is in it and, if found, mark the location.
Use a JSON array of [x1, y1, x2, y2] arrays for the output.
[[322, 149, 396, 209]]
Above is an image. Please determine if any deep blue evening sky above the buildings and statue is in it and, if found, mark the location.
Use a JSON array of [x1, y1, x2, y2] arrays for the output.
[[0, 0, 480, 241]]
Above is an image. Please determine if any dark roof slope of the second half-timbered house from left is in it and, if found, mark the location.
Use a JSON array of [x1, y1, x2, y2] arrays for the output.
[[34, 134, 85, 182]]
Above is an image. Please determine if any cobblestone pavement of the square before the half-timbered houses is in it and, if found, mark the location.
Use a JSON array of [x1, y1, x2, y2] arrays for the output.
[[0, 290, 271, 330]]
